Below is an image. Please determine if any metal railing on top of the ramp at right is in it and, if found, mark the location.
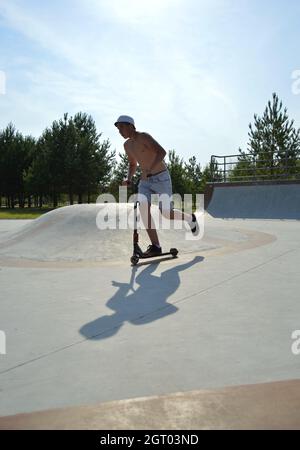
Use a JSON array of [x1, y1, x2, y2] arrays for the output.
[[210, 152, 300, 183]]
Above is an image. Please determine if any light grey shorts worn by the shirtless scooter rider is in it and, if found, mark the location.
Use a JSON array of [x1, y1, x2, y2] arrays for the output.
[[138, 170, 173, 209]]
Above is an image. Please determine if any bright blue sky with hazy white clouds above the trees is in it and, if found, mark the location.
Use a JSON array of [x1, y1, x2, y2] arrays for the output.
[[0, 0, 300, 165]]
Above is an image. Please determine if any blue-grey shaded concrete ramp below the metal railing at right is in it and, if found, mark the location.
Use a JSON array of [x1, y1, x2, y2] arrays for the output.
[[207, 183, 300, 220]]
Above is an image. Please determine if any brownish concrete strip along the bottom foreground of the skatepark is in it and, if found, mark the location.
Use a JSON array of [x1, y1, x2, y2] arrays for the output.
[[0, 380, 300, 430]]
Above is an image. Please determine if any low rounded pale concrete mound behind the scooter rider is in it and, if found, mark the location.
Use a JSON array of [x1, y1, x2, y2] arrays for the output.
[[0, 203, 274, 267]]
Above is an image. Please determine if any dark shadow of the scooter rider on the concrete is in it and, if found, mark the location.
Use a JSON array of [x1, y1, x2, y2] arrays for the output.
[[79, 256, 204, 340]]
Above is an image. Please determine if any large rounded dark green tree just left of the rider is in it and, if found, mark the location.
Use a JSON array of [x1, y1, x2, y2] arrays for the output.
[[34, 113, 114, 207]]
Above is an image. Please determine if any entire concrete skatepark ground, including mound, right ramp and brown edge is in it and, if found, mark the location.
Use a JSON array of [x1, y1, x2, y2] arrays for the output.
[[0, 185, 300, 430]]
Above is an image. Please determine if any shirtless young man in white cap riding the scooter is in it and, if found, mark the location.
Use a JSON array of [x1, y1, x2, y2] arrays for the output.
[[115, 116, 199, 256]]
